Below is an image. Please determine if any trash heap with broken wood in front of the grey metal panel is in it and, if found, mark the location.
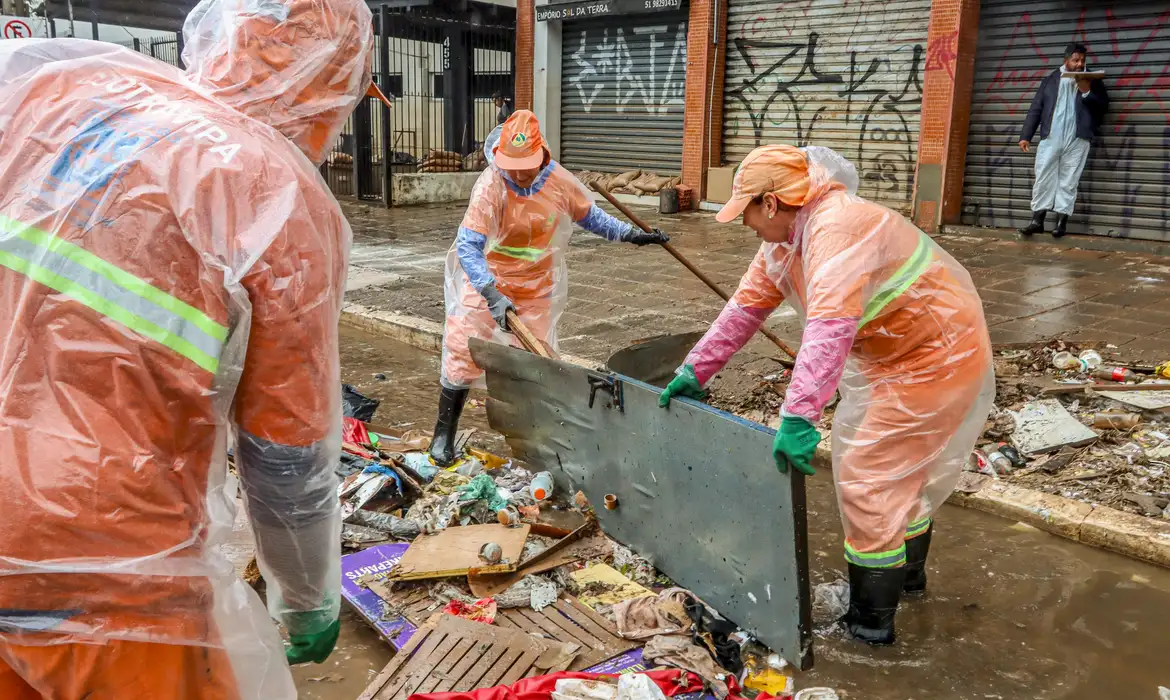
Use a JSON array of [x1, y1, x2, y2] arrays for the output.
[[325, 385, 835, 700]]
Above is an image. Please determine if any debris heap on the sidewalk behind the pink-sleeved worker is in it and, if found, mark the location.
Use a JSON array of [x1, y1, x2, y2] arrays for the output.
[[708, 339, 1170, 520]]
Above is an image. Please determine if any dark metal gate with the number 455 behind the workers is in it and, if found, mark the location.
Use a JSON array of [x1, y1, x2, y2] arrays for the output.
[[322, 7, 515, 206]]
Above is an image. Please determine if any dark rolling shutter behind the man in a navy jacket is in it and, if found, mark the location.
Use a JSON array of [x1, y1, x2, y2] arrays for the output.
[[962, 0, 1170, 241]]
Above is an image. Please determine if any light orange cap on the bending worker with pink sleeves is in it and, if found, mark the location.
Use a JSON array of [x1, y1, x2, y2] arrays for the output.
[[715, 145, 808, 224]]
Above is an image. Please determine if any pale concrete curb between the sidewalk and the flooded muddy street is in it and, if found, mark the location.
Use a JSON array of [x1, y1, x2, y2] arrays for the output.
[[342, 303, 1170, 568]]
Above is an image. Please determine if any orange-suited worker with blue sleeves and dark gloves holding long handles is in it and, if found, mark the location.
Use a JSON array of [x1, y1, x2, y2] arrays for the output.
[[431, 110, 670, 466]]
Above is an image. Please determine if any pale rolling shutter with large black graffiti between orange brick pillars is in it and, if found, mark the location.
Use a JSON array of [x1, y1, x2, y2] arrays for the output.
[[723, 0, 930, 212]]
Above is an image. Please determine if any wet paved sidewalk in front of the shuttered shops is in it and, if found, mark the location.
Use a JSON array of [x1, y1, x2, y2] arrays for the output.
[[343, 200, 1170, 361]]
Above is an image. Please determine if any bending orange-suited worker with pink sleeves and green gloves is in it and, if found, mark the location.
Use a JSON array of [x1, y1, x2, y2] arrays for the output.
[[660, 145, 995, 644]]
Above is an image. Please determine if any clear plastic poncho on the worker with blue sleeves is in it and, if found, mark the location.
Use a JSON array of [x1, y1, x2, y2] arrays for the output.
[[442, 126, 633, 389]]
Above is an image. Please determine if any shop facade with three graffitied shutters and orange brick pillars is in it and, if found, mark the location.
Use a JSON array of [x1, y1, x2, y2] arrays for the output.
[[517, 0, 1170, 240]]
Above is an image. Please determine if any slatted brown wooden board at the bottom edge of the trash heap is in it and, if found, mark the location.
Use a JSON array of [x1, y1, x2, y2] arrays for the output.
[[358, 615, 583, 700]]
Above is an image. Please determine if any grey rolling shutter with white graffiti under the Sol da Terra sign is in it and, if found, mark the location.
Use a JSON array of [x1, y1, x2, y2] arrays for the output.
[[560, 13, 687, 174]]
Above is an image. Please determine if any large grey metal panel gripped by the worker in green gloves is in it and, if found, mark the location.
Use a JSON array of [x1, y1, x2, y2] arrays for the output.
[[472, 339, 812, 668]]
